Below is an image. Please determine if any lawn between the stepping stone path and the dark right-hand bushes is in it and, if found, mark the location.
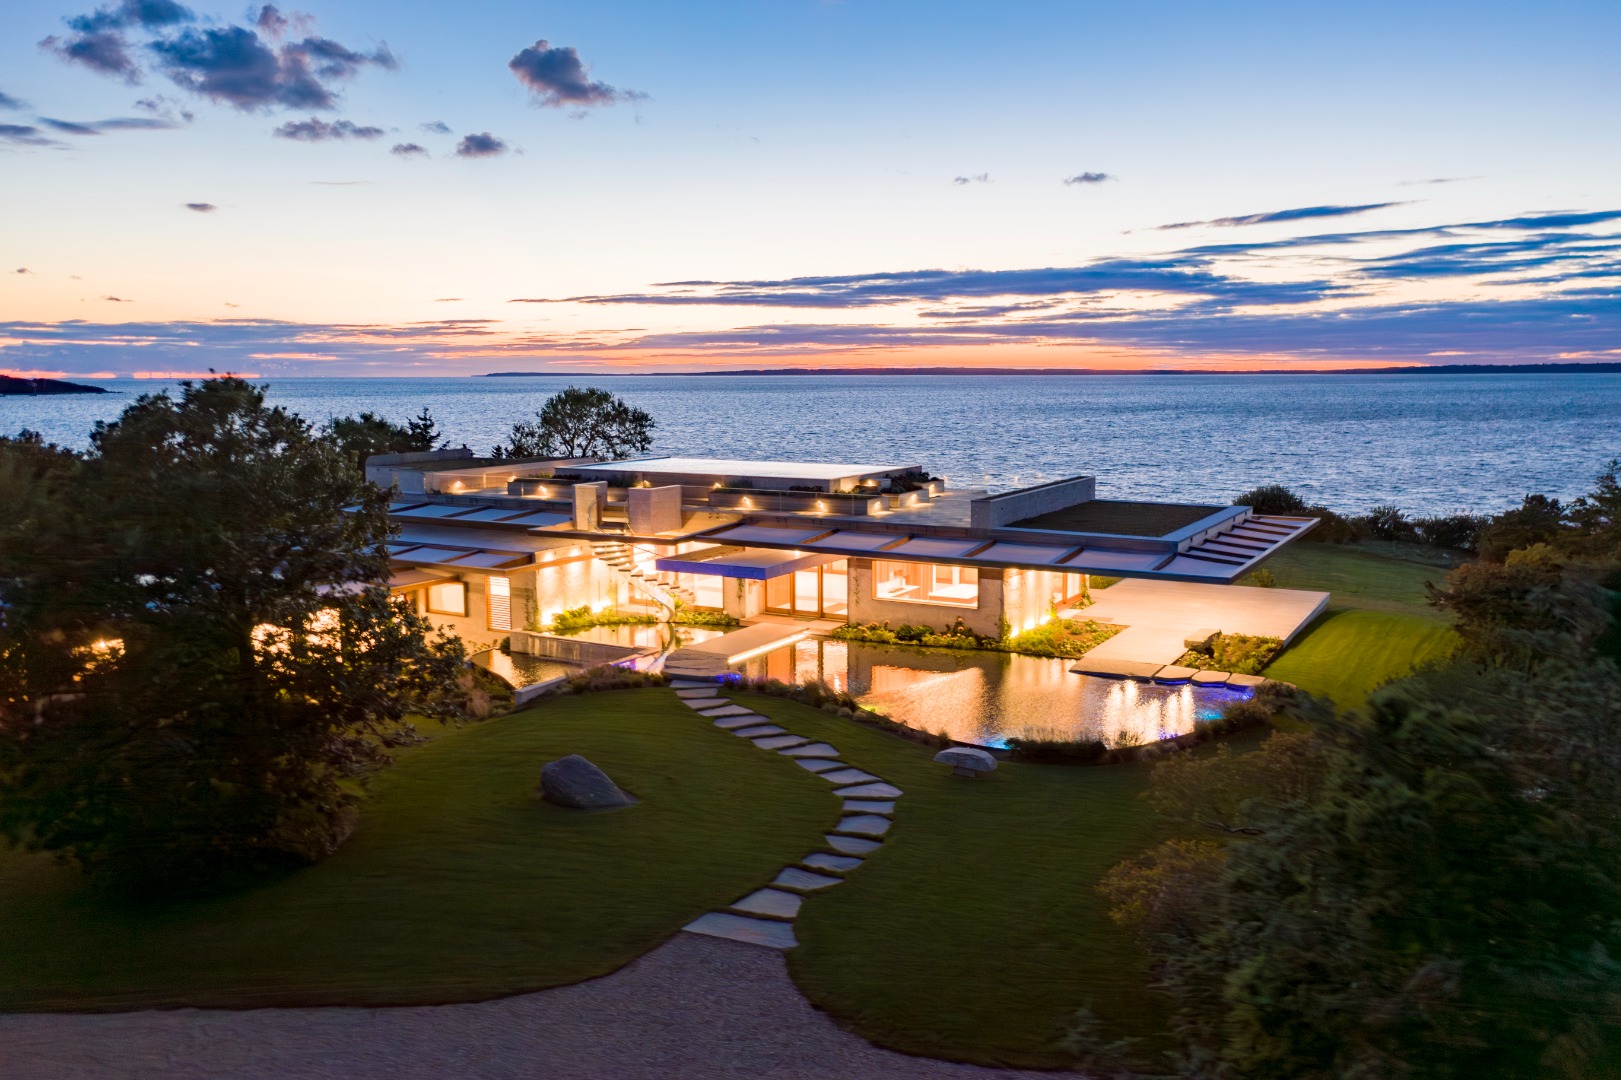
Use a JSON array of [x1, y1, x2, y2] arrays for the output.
[[738, 694, 1164, 1067]]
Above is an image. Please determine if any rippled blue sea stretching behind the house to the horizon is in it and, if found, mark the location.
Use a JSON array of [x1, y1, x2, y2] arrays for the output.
[[0, 375, 1621, 512]]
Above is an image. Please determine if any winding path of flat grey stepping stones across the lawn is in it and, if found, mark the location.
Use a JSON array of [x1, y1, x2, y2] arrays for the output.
[[671, 679, 903, 949]]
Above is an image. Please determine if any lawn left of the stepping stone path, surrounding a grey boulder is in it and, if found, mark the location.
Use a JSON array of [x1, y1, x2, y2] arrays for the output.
[[0, 689, 836, 1010]]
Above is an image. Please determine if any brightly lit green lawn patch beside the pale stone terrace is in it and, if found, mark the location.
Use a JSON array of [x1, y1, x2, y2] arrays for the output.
[[1264, 610, 1457, 709]]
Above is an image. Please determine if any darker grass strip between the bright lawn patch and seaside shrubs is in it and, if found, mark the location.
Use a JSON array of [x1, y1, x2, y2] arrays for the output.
[[1266, 543, 1456, 612]]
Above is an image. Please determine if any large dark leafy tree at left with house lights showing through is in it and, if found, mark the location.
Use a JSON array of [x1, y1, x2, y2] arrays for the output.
[[0, 378, 462, 890]]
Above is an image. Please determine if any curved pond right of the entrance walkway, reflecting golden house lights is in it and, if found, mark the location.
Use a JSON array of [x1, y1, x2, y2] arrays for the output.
[[739, 639, 1247, 748]]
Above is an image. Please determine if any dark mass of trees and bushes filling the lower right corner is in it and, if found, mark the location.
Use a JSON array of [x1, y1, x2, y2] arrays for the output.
[[1102, 606, 1621, 1080]]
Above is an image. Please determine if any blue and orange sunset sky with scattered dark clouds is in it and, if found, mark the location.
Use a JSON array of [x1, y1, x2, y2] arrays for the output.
[[0, 0, 1621, 378]]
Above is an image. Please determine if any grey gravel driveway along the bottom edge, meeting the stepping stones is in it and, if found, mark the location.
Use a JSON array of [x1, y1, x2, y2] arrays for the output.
[[0, 934, 1052, 1080]]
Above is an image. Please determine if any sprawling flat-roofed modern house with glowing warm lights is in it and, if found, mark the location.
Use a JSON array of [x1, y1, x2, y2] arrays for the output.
[[366, 449, 1316, 647]]
